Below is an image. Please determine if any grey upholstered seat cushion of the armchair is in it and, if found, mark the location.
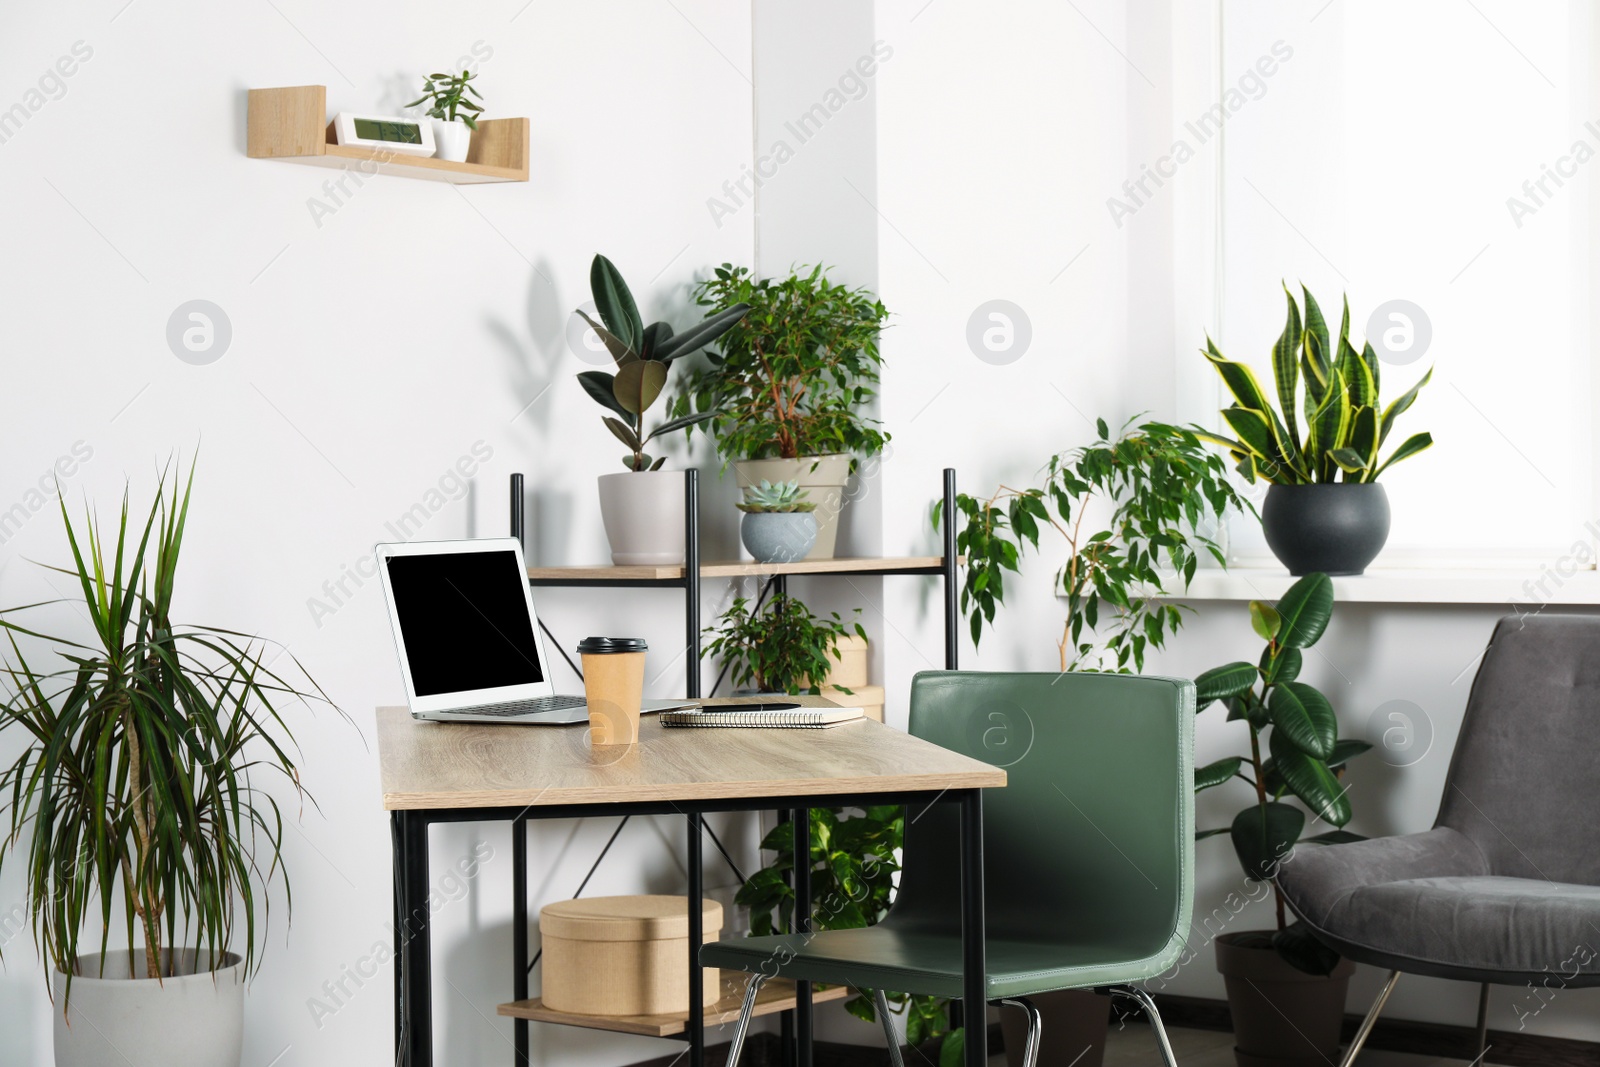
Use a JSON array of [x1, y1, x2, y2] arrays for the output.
[[1314, 875, 1600, 985]]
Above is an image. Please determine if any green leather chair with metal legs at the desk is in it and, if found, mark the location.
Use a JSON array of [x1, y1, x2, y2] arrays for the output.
[[701, 672, 1195, 1067]]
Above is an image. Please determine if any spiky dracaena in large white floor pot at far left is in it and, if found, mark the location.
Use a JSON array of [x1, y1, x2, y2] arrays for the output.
[[0, 469, 326, 1067]]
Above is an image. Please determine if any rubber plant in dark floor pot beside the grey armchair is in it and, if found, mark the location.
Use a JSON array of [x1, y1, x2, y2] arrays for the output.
[[1195, 573, 1371, 1067]]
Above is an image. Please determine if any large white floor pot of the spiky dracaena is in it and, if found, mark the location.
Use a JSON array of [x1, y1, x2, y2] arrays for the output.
[[53, 949, 245, 1067]]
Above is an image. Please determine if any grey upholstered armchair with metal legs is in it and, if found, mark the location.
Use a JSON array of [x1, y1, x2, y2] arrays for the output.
[[1278, 614, 1600, 1067]]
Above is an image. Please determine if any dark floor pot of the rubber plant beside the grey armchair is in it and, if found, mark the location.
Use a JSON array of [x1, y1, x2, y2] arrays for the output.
[[1214, 931, 1355, 1067]]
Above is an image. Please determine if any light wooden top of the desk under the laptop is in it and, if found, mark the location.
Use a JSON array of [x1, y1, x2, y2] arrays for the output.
[[378, 697, 1005, 811]]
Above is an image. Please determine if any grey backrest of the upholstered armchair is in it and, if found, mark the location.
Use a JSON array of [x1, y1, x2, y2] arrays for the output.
[[1437, 614, 1600, 886]]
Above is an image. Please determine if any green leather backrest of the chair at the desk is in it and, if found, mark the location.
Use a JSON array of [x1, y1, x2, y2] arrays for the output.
[[890, 672, 1195, 974]]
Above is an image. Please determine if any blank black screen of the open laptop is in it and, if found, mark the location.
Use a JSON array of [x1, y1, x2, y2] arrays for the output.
[[389, 549, 544, 696]]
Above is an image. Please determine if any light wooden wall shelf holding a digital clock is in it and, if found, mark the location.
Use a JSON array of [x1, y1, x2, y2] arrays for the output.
[[246, 85, 528, 186]]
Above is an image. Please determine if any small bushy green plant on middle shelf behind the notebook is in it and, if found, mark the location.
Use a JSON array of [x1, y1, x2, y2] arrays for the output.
[[701, 593, 867, 696]]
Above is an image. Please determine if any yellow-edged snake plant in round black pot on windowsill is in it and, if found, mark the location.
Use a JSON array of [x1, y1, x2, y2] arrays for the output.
[[1203, 286, 1434, 576]]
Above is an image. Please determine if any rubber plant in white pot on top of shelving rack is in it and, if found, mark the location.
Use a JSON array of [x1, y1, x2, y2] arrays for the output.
[[578, 256, 749, 566]]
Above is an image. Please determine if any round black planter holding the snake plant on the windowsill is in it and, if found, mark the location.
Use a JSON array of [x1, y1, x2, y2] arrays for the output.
[[1261, 482, 1389, 577]]
